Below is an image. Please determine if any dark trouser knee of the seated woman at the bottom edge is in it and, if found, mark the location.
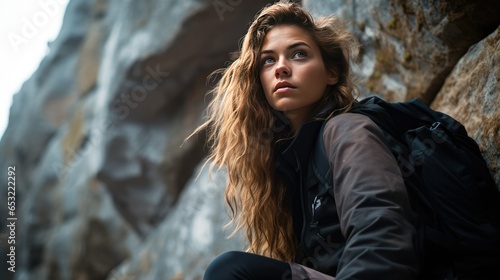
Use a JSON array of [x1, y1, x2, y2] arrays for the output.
[[203, 251, 292, 280]]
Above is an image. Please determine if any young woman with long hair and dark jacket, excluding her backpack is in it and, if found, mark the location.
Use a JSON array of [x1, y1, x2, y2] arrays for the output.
[[198, 2, 418, 280]]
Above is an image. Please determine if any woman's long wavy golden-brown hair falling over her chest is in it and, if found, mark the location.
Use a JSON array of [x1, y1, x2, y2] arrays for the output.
[[195, 1, 359, 261]]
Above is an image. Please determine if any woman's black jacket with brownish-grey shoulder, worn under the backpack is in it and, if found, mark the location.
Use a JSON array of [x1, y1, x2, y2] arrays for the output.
[[276, 113, 418, 280]]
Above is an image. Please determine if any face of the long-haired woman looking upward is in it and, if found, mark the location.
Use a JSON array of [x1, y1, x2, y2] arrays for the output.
[[260, 25, 338, 131]]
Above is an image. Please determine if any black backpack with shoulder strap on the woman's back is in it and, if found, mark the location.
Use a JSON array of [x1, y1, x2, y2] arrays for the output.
[[314, 97, 500, 279]]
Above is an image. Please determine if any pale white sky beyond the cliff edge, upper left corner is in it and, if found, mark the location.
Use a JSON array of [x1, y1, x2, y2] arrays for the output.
[[0, 0, 68, 140]]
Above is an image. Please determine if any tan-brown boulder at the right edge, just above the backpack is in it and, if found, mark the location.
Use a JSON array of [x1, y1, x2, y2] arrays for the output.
[[431, 27, 500, 188]]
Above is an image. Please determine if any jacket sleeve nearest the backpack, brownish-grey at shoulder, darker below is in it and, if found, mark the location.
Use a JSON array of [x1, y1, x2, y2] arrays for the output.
[[323, 113, 418, 280]]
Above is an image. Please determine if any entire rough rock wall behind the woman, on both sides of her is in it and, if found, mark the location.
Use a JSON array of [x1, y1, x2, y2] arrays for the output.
[[0, 0, 500, 280]]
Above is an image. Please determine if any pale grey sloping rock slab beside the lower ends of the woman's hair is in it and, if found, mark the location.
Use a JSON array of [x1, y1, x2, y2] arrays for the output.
[[108, 164, 245, 280]]
